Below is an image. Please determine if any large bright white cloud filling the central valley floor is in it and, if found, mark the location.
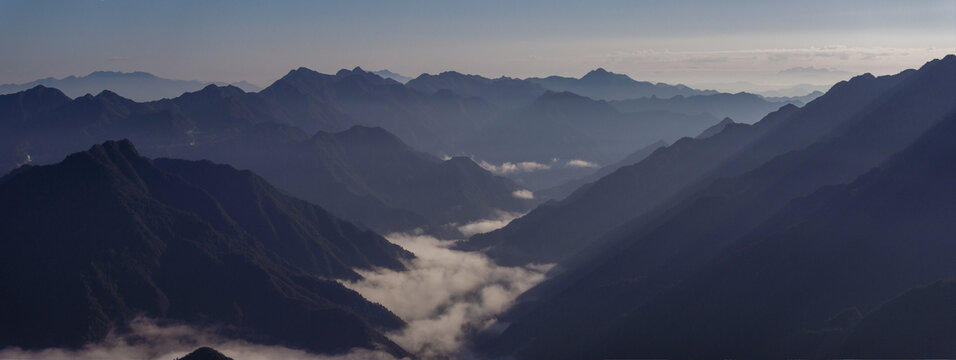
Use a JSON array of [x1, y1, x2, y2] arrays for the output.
[[345, 232, 551, 358]]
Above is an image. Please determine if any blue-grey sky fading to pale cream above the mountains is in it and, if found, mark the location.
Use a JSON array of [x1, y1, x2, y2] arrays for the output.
[[0, 0, 956, 90]]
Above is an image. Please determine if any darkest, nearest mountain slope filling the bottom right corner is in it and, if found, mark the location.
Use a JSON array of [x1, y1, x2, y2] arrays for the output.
[[600, 109, 956, 358]]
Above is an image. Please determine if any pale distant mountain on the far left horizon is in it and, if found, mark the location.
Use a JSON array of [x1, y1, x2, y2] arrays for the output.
[[0, 71, 262, 101]]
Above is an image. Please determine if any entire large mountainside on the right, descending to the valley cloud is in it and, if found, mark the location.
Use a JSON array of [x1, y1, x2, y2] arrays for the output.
[[471, 55, 956, 358]]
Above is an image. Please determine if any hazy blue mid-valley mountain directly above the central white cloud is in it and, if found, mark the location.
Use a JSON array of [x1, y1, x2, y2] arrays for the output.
[[224, 126, 534, 236]]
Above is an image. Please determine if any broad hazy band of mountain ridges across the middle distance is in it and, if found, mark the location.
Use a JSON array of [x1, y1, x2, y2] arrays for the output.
[[0, 68, 784, 194]]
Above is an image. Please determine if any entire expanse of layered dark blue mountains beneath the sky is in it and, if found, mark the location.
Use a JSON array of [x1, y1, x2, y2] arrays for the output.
[[0, 55, 956, 359]]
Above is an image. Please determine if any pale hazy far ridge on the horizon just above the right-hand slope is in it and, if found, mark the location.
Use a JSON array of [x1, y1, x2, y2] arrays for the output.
[[611, 93, 805, 124]]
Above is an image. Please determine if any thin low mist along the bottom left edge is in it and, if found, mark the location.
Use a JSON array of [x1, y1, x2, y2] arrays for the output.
[[0, 317, 395, 360]]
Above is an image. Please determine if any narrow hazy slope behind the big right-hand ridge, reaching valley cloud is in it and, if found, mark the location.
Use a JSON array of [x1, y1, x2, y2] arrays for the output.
[[460, 106, 776, 263]]
